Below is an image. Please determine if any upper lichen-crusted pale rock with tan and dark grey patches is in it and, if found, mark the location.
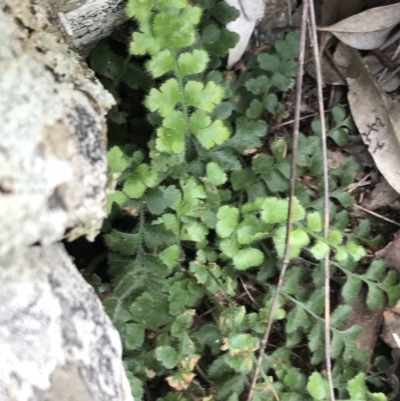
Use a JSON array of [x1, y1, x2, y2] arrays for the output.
[[0, 0, 114, 260]]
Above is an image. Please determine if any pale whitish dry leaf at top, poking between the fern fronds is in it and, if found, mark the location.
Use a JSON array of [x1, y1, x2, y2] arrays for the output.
[[226, 0, 265, 68]]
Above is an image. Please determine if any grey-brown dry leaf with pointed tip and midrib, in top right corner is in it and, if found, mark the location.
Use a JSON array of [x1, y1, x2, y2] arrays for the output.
[[318, 4, 400, 50]]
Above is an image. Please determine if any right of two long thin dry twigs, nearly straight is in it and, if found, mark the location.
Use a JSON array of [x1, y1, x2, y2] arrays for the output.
[[309, 1, 335, 401]]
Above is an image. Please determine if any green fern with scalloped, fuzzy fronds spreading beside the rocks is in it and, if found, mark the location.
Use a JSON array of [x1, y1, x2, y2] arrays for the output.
[[86, 0, 400, 401]]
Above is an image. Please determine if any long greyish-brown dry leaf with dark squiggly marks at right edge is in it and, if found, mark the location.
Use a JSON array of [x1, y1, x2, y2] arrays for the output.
[[340, 45, 400, 193]]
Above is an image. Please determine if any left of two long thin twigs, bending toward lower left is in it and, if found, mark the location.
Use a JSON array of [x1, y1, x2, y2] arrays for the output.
[[247, 0, 309, 401]]
